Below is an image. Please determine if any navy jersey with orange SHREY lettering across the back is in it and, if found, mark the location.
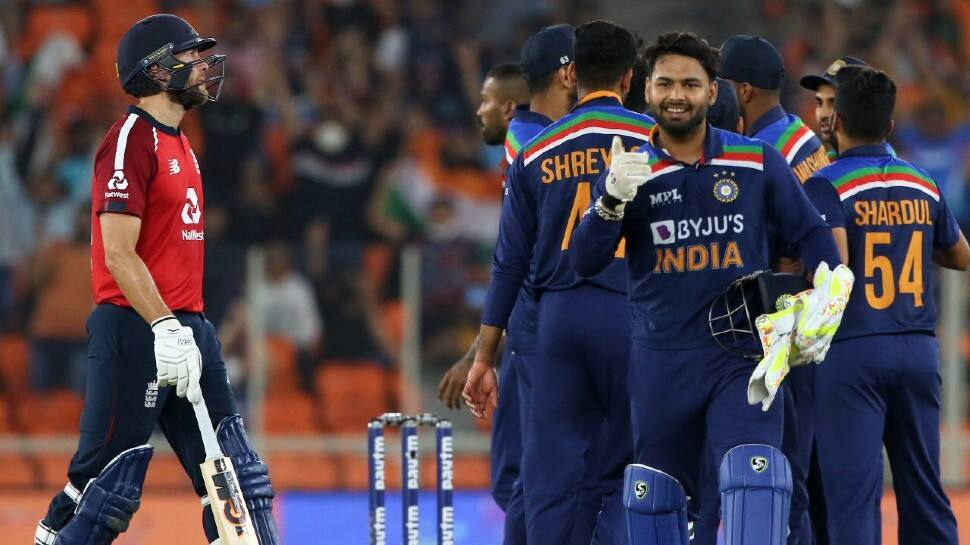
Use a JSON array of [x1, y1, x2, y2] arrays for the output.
[[482, 91, 653, 328]]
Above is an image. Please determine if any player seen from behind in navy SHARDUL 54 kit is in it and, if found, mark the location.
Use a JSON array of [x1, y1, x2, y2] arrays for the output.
[[805, 66, 970, 545]]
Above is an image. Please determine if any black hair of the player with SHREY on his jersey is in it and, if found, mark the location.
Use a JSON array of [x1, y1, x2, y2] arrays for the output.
[[573, 21, 637, 89]]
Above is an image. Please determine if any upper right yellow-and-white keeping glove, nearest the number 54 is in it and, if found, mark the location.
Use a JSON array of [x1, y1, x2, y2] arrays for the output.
[[792, 261, 855, 365]]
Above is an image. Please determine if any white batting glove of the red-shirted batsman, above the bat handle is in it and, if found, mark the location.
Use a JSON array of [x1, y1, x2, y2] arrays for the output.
[[152, 316, 202, 403]]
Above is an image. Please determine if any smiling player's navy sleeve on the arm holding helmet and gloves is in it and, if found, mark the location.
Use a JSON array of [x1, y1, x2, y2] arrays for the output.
[[762, 144, 842, 271]]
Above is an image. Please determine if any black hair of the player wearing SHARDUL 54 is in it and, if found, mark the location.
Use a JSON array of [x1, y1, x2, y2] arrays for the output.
[[835, 65, 896, 141]]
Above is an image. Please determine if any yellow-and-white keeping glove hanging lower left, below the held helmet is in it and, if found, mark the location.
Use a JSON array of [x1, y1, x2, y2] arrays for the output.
[[748, 292, 804, 411]]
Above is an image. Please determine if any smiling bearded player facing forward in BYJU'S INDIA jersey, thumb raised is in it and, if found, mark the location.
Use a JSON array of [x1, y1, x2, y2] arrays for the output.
[[570, 33, 839, 545]]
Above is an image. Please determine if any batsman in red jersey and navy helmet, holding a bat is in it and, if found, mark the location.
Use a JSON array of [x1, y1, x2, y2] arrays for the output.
[[34, 15, 280, 545]]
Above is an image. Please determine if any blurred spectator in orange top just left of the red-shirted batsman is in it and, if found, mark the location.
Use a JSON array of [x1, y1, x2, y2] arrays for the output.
[[29, 203, 94, 392]]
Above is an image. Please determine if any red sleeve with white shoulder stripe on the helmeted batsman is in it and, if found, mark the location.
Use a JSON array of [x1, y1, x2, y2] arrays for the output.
[[91, 122, 156, 217]]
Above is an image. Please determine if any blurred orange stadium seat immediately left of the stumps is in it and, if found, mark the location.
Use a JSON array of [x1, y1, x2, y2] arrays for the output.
[[316, 362, 389, 433]]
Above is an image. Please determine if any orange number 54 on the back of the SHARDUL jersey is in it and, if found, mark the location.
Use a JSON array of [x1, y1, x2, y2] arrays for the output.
[[865, 231, 923, 310]]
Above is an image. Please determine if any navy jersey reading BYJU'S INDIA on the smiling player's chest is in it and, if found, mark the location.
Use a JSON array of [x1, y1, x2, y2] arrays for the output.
[[572, 125, 839, 350]]
